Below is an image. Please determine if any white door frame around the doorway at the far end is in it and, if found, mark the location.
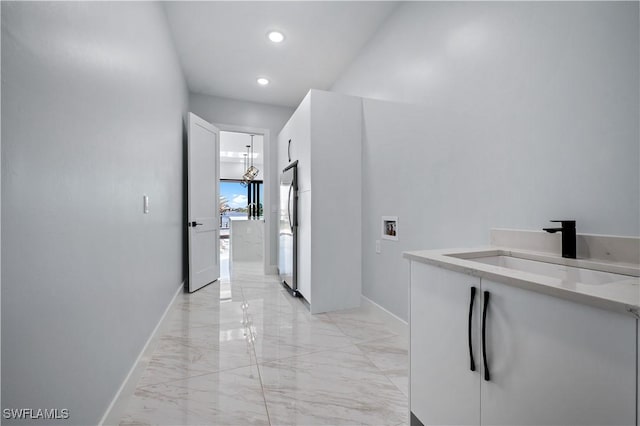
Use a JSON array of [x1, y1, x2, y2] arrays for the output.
[[211, 123, 278, 275]]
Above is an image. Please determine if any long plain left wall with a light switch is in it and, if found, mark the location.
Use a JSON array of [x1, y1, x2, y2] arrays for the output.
[[2, 2, 188, 425]]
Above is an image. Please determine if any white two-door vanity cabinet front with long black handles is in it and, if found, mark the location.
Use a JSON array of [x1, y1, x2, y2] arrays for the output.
[[410, 261, 637, 426]]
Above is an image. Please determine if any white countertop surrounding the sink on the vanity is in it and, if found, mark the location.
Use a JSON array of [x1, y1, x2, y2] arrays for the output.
[[403, 246, 640, 318]]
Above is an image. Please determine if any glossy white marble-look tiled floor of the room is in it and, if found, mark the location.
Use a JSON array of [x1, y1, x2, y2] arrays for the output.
[[119, 264, 408, 426]]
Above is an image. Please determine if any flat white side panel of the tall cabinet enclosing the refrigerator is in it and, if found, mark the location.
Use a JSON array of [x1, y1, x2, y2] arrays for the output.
[[310, 90, 362, 313]]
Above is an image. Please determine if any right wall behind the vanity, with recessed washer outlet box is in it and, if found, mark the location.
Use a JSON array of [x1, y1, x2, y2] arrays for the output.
[[333, 2, 640, 319]]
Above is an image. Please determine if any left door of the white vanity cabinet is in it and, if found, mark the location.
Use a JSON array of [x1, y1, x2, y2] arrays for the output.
[[409, 262, 481, 425]]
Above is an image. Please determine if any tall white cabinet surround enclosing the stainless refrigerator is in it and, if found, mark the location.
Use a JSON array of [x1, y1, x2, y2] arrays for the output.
[[278, 90, 362, 313]]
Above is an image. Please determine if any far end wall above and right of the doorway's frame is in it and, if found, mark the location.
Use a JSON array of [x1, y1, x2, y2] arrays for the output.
[[189, 93, 294, 268]]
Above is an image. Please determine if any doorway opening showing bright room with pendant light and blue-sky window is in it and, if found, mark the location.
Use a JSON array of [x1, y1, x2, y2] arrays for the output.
[[219, 131, 267, 277]]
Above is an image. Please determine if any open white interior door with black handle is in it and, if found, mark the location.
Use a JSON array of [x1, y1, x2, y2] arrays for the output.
[[187, 113, 220, 292]]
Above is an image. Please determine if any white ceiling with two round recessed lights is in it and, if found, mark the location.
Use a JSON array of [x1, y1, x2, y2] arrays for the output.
[[163, 1, 397, 107]]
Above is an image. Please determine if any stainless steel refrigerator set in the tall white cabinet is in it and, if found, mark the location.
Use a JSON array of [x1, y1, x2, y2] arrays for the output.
[[278, 161, 300, 296]]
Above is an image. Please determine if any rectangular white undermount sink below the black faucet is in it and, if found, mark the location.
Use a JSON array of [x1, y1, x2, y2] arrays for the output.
[[451, 255, 632, 285]]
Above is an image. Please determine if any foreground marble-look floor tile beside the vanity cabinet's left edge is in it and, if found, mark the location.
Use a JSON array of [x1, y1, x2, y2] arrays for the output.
[[259, 346, 407, 425]]
